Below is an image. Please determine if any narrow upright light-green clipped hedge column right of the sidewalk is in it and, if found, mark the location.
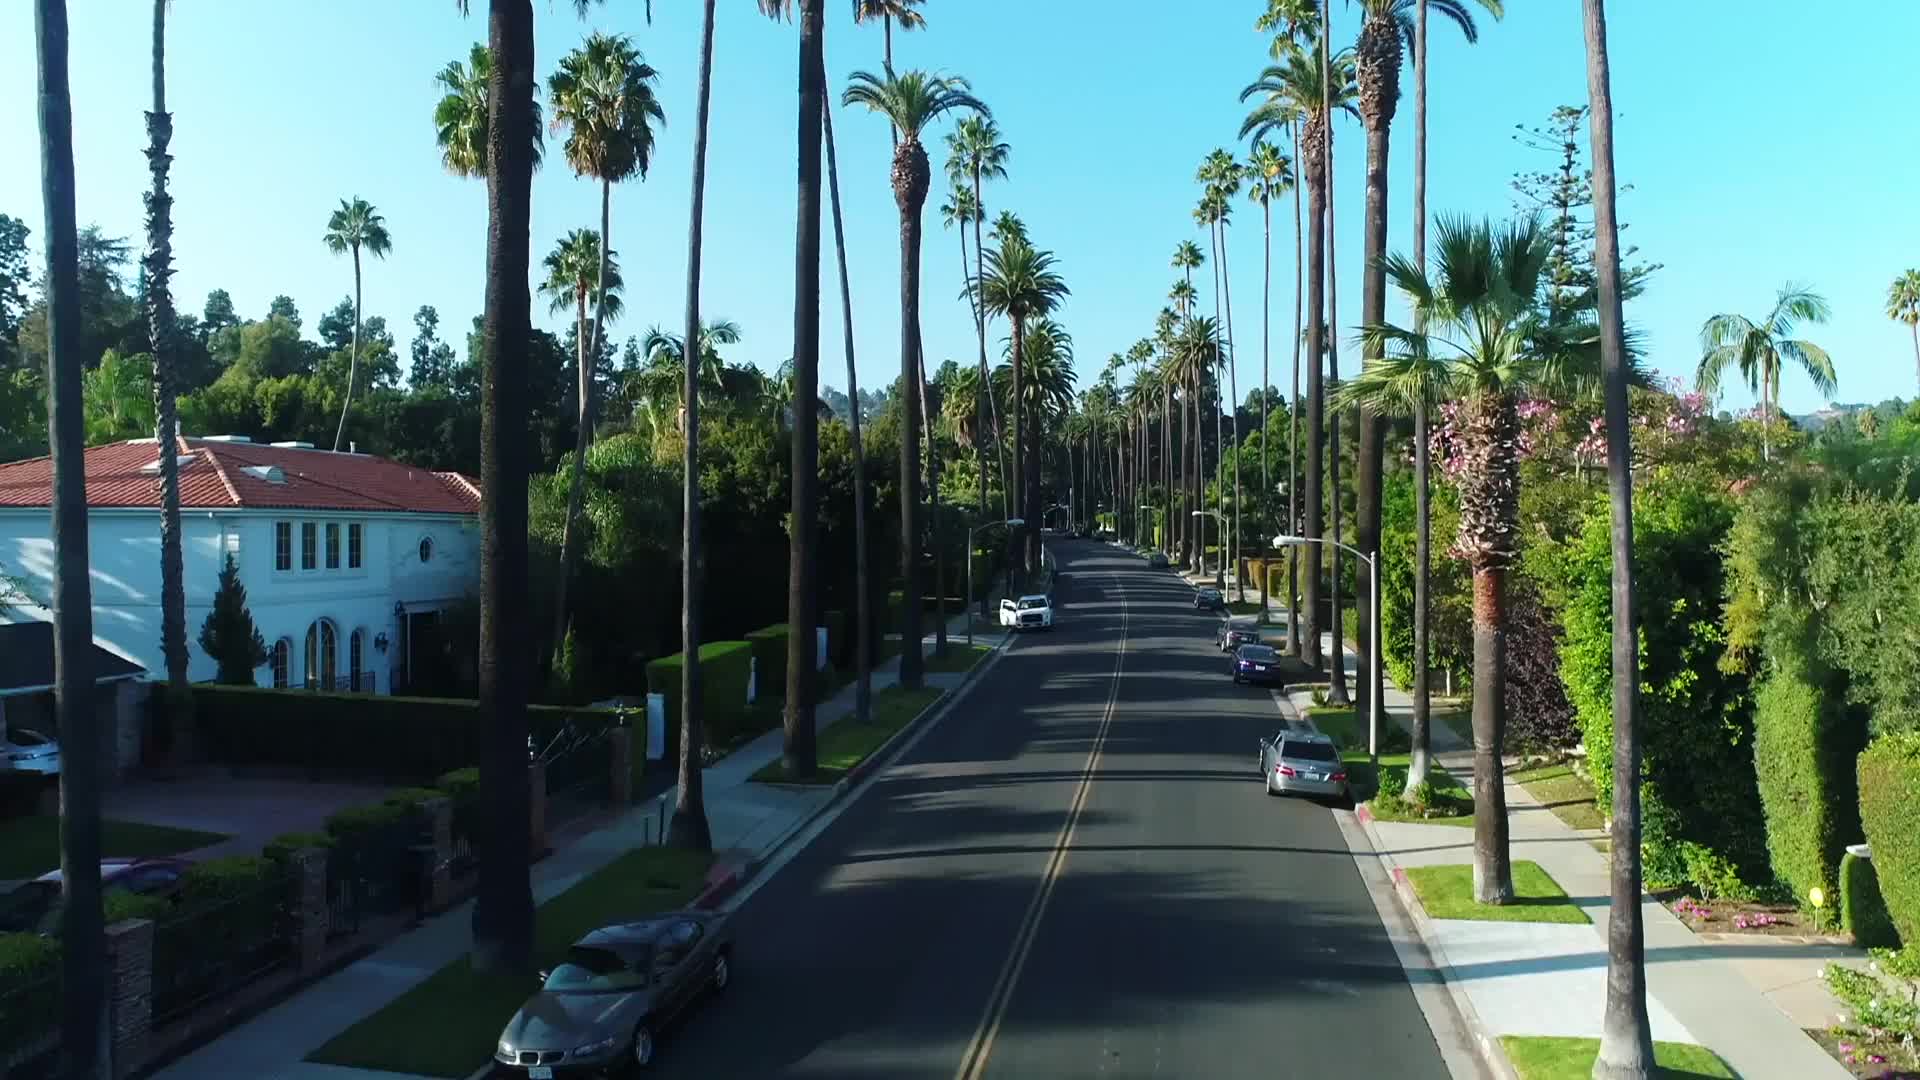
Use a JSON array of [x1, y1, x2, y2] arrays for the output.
[[1753, 653, 1862, 897]]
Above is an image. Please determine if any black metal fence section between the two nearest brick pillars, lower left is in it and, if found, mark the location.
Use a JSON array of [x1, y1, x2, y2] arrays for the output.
[[154, 871, 294, 1028]]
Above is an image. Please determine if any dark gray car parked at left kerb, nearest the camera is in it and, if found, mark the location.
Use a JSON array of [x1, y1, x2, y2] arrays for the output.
[[493, 911, 733, 1080]]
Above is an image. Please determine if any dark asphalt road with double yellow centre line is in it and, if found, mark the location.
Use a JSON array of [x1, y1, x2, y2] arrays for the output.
[[657, 542, 1448, 1080]]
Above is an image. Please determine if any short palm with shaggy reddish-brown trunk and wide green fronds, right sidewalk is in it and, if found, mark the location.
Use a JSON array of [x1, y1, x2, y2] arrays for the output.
[[1334, 217, 1612, 903]]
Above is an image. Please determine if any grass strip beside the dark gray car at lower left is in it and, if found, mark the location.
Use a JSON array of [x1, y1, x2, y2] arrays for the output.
[[307, 847, 712, 1078]]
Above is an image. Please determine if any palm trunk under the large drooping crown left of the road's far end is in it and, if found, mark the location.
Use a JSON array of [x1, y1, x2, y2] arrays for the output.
[[894, 152, 925, 690]]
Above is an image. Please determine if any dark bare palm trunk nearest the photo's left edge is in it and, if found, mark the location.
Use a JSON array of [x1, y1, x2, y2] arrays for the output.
[[33, 0, 108, 1076]]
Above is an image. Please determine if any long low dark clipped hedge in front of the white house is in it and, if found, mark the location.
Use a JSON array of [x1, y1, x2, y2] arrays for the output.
[[194, 684, 645, 782]]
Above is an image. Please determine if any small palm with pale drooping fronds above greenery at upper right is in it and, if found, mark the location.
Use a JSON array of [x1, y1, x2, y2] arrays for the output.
[[1693, 282, 1839, 461]]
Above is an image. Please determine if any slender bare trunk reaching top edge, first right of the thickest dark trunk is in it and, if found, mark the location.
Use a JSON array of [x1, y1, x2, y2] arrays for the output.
[[664, 0, 718, 851]]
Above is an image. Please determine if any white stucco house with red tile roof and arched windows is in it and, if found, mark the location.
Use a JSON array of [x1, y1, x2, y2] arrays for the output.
[[0, 436, 480, 694]]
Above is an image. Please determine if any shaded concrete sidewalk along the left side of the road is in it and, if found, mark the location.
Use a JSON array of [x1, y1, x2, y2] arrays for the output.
[[154, 617, 1004, 1080]]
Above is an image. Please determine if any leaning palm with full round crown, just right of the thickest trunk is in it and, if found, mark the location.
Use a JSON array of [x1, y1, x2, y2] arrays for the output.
[[547, 33, 666, 655]]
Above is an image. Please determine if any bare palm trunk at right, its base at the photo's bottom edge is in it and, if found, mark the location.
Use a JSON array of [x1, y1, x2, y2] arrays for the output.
[[1584, 0, 1653, 1080]]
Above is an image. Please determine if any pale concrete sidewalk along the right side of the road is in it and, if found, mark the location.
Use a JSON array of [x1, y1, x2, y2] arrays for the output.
[[1288, 626, 1860, 1080]]
